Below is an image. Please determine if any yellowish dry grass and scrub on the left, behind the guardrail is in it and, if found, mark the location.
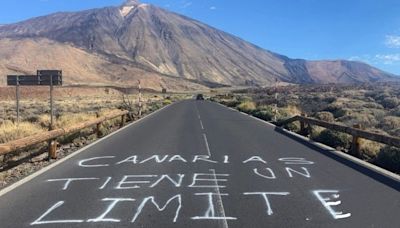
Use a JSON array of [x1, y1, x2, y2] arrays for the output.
[[0, 87, 188, 158]]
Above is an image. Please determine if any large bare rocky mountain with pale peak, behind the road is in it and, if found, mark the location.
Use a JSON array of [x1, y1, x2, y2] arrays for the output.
[[0, 0, 395, 89]]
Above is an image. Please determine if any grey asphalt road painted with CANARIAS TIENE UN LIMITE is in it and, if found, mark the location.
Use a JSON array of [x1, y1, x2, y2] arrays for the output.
[[0, 101, 400, 228]]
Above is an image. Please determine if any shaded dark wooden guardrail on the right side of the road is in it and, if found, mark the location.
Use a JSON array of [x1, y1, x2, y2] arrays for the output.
[[276, 116, 400, 157]]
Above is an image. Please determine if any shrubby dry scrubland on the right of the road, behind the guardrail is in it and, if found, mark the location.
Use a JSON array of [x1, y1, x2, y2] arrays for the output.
[[212, 83, 400, 172]]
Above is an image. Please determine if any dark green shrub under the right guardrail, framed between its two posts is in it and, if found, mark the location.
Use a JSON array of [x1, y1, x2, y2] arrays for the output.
[[314, 129, 350, 149]]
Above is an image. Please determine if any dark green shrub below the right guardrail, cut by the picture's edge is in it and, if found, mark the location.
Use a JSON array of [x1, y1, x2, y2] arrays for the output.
[[374, 146, 400, 173]]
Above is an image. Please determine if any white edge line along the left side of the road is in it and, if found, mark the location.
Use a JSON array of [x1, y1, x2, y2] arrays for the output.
[[0, 102, 173, 197]]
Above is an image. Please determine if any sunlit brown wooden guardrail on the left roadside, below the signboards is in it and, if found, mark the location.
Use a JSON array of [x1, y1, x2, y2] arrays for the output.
[[0, 111, 129, 159]]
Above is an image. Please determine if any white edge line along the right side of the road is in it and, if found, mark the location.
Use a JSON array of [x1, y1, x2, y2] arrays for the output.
[[214, 102, 400, 182]]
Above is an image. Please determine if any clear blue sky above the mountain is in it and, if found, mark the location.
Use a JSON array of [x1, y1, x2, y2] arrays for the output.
[[0, 0, 400, 75]]
